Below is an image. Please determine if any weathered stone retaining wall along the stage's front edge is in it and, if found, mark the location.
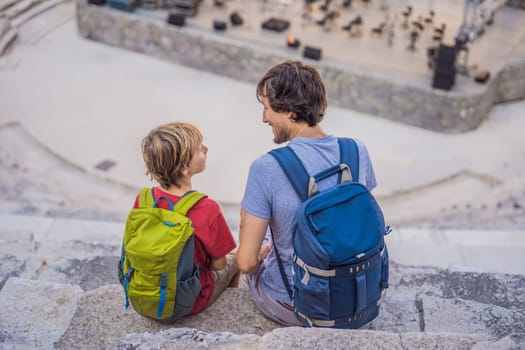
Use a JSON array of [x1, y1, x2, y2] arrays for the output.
[[77, 0, 525, 132]]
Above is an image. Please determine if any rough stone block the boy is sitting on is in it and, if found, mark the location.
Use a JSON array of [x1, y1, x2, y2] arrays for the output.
[[56, 285, 281, 349]]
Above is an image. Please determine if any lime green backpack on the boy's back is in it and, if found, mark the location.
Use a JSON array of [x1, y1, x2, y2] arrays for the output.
[[119, 188, 206, 321]]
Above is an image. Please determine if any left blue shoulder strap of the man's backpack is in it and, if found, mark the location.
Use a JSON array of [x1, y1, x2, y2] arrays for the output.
[[269, 146, 310, 202]]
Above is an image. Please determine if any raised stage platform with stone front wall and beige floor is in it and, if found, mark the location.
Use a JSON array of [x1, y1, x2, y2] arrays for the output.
[[77, 0, 525, 132]]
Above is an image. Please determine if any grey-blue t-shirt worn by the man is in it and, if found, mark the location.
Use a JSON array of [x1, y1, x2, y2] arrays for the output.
[[241, 136, 376, 303]]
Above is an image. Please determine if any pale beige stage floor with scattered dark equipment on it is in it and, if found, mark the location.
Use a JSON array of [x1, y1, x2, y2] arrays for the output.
[[137, 0, 525, 92]]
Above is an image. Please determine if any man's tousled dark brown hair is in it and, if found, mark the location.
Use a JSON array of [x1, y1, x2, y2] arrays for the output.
[[257, 61, 327, 126]]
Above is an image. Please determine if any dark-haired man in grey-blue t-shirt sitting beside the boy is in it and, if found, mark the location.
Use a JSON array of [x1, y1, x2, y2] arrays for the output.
[[236, 61, 376, 326]]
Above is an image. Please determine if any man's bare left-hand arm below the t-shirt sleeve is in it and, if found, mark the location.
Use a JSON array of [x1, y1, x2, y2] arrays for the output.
[[236, 209, 268, 273]]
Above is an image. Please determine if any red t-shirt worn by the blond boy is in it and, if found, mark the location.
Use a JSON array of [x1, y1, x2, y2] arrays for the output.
[[133, 187, 236, 314]]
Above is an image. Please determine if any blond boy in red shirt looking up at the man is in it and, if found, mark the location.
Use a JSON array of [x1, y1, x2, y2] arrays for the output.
[[138, 122, 238, 314]]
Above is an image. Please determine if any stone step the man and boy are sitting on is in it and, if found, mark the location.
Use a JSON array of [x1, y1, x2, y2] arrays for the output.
[[0, 277, 525, 349]]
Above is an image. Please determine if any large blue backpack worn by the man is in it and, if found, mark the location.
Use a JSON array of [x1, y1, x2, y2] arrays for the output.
[[270, 138, 390, 328]]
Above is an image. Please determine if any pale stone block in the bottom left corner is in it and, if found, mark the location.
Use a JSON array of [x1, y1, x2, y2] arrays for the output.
[[0, 278, 82, 348]]
